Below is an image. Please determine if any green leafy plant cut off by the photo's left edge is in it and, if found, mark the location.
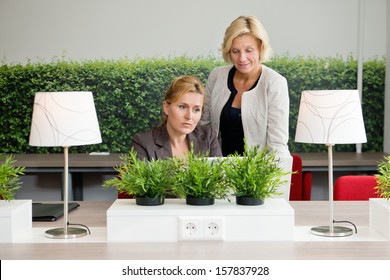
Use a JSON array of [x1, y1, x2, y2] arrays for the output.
[[0, 155, 25, 200]]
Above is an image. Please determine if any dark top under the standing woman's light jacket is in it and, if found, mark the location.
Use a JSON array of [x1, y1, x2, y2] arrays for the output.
[[220, 67, 258, 156]]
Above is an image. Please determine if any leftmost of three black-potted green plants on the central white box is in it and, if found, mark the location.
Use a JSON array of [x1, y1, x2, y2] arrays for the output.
[[103, 148, 172, 205]]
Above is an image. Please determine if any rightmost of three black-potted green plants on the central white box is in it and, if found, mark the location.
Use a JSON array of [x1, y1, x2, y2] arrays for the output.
[[224, 144, 291, 205]]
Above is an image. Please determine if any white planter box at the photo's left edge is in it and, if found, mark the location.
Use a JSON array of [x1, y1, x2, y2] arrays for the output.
[[0, 200, 32, 243]]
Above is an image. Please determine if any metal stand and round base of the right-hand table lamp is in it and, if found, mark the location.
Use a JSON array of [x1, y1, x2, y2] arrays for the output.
[[311, 144, 353, 237]]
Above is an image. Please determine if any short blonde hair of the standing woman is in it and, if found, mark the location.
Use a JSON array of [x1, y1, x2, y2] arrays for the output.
[[221, 16, 272, 63]]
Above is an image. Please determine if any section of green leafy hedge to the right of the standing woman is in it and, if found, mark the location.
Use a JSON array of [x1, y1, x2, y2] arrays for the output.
[[270, 57, 385, 152]]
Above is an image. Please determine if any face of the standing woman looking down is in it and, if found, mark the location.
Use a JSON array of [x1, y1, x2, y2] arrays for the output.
[[230, 34, 260, 74]]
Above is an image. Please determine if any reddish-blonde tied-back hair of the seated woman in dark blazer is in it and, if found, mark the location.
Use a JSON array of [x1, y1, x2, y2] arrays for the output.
[[163, 75, 205, 123]]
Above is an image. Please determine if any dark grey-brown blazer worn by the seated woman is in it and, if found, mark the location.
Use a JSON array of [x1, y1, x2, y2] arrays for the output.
[[131, 125, 222, 160]]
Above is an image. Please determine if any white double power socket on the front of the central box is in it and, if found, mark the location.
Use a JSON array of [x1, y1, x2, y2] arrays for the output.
[[178, 216, 224, 240]]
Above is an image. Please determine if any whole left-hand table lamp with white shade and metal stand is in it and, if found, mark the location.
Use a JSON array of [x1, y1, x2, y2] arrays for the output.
[[29, 92, 102, 239]]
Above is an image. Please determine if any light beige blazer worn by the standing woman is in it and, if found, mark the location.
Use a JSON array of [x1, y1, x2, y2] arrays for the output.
[[199, 65, 290, 157]]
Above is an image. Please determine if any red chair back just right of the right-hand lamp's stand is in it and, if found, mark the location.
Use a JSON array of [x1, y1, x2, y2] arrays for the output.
[[333, 175, 380, 200]]
